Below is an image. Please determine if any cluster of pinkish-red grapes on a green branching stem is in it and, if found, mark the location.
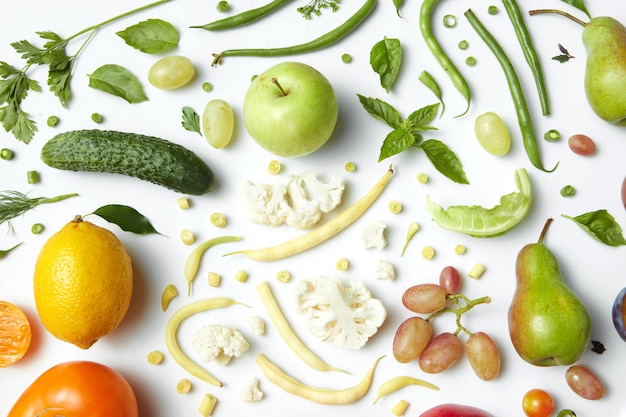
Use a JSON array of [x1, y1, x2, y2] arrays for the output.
[[392, 266, 500, 381]]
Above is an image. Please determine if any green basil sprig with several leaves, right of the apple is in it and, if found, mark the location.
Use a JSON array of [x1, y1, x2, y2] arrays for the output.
[[357, 94, 469, 184]]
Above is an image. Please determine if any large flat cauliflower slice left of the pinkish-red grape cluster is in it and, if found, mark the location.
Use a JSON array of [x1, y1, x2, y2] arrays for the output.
[[293, 275, 387, 350]]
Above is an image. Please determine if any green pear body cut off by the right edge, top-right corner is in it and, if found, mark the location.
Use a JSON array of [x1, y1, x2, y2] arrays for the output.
[[582, 17, 626, 124]]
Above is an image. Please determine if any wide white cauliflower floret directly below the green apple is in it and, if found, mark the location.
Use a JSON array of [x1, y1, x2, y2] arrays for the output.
[[241, 171, 345, 229]]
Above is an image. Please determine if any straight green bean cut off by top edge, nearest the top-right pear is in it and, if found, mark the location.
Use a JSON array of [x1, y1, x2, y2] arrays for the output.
[[502, 0, 550, 116]]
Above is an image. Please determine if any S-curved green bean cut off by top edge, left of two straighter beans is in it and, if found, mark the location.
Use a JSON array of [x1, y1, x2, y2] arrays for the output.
[[419, 0, 472, 117]]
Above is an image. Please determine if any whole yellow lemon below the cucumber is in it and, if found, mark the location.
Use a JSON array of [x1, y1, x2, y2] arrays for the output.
[[33, 216, 133, 349]]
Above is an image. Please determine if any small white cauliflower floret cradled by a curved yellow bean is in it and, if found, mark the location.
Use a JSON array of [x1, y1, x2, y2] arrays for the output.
[[191, 324, 250, 365]]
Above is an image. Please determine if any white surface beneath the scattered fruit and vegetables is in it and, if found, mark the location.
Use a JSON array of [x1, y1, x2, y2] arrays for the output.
[[0, 0, 626, 417]]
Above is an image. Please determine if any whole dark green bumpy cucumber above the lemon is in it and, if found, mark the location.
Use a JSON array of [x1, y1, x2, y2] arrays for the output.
[[41, 129, 214, 195]]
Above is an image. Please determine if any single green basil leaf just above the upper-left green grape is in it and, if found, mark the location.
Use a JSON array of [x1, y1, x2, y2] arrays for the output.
[[116, 19, 179, 54]]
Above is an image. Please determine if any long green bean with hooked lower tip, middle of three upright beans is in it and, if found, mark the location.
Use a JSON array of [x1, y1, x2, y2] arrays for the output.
[[465, 9, 559, 172]]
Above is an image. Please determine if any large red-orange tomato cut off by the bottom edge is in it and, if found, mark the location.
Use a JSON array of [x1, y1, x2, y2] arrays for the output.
[[7, 361, 139, 417]]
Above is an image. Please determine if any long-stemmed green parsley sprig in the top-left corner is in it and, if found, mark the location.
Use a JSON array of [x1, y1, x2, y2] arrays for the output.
[[0, 0, 170, 143]]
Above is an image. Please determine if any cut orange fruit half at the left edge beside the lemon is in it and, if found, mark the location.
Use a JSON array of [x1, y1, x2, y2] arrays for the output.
[[0, 301, 32, 368]]
